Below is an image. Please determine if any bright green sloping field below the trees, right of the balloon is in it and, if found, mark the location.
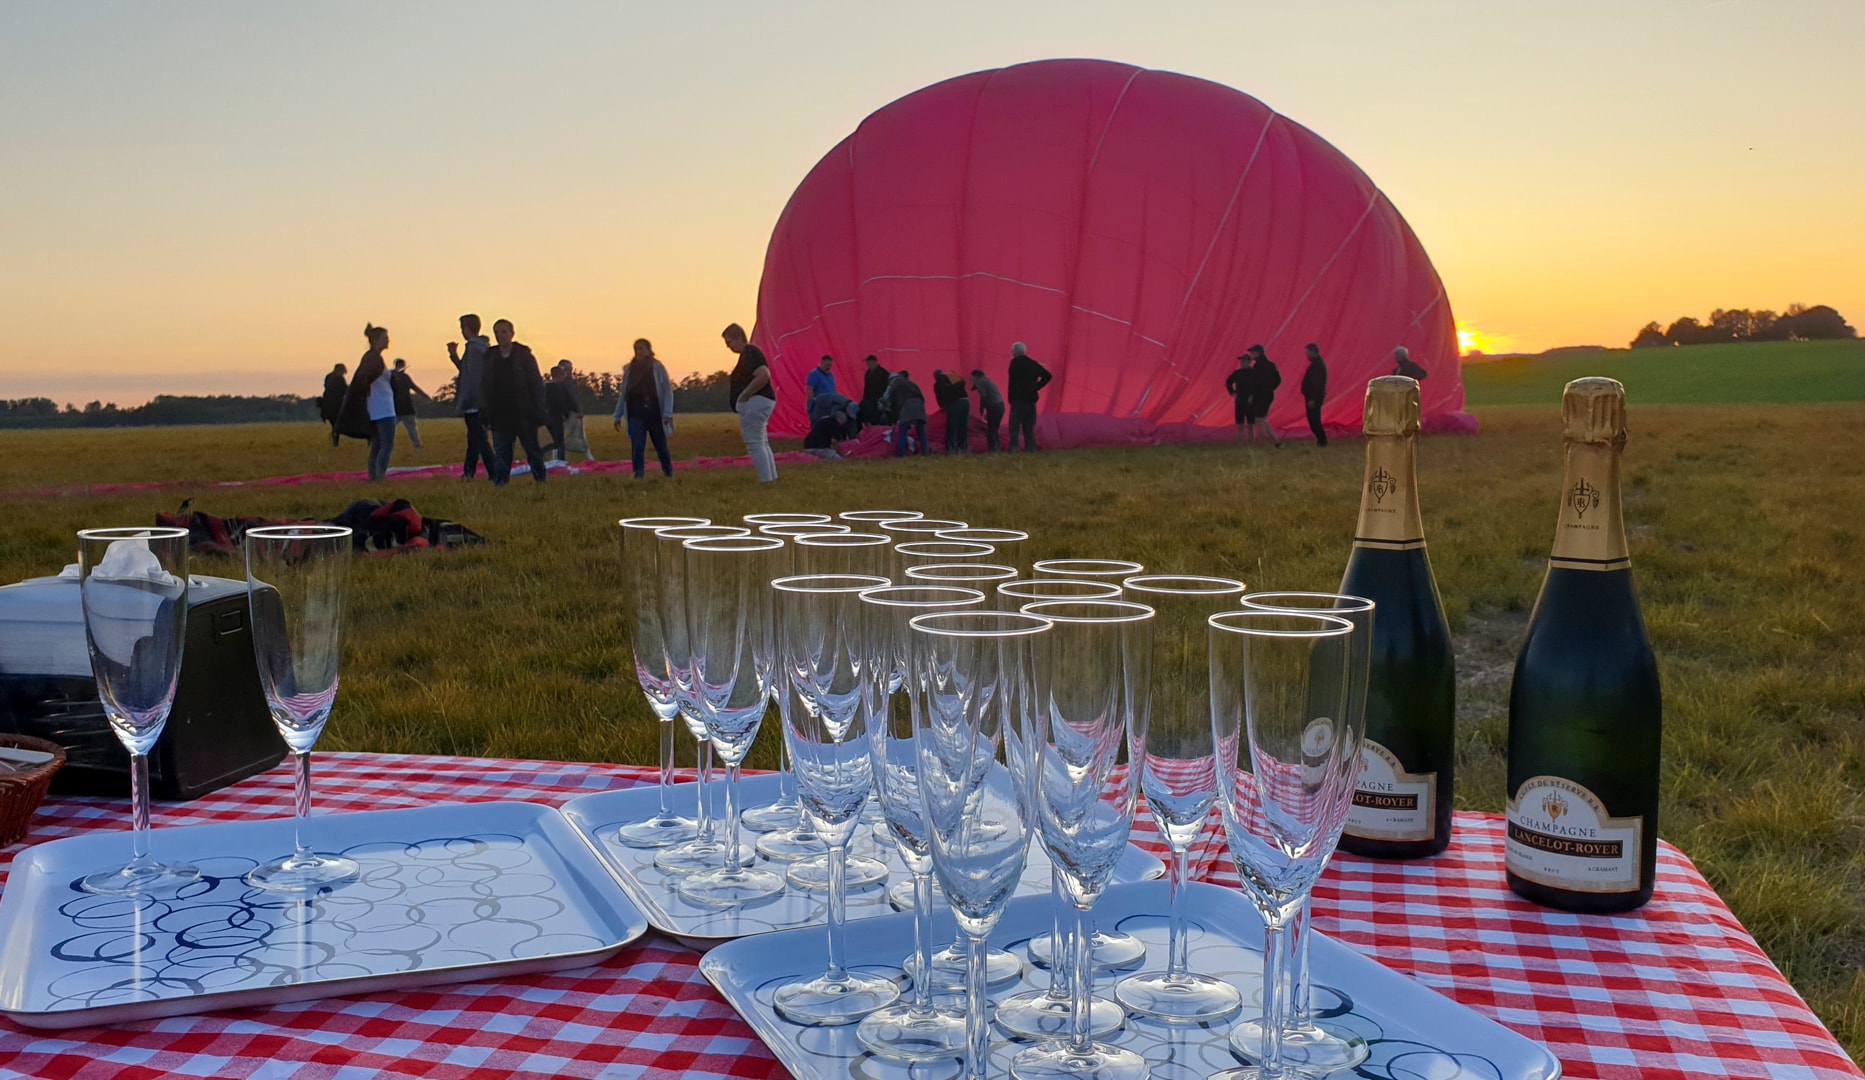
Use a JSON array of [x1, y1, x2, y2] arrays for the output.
[[1464, 341, 1865, 408]]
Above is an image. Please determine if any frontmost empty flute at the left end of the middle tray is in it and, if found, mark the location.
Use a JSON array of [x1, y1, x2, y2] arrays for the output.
[[666, 535, 783, 907]]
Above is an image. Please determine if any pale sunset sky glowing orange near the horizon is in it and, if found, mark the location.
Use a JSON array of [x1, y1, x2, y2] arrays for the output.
[[0, 0, 1865, 405]]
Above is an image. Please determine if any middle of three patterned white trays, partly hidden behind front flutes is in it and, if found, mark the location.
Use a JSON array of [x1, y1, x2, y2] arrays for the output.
[[563, 772, 1166, 948]]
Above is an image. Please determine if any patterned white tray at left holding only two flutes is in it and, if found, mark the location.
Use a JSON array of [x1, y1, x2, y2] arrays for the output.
[[0, 802, 647, 1028]]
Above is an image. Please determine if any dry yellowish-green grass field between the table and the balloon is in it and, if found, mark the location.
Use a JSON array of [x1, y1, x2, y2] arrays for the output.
[[0, 382, 1865, 1056]]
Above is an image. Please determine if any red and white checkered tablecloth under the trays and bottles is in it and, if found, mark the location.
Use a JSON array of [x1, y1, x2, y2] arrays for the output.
[[0, 754, 1861, 1080]]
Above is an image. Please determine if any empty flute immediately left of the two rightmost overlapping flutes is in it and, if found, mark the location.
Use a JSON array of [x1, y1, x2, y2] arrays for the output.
[[1113, 576, 1244, 1024]]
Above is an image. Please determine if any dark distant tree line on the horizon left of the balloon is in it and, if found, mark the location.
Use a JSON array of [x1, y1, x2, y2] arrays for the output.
[[0, 371, 731, 427]]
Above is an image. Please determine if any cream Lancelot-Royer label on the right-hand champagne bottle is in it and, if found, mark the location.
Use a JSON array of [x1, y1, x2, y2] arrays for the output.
[[1503, 776, 1645, 892]]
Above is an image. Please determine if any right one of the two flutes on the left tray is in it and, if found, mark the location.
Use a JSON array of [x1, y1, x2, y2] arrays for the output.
[[241, 524, 362, 893]]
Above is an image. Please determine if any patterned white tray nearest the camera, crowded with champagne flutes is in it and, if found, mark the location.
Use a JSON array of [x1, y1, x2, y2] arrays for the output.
[[699, 882, 1561, 1080]]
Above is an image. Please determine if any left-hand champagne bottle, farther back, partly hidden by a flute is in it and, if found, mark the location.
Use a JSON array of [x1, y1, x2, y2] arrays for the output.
[[1341, 375, 1457, 858]]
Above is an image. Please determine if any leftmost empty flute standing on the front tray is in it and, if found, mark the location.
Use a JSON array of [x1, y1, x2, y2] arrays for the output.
[[772, 574, 901, 1026]]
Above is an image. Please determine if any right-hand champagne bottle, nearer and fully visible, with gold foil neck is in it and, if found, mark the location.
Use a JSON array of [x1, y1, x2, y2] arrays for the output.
[[1503, 379, 1664, 912]]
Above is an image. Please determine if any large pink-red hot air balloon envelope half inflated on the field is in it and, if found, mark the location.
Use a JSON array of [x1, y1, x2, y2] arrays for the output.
[[753, 60, 1475, 446]]
